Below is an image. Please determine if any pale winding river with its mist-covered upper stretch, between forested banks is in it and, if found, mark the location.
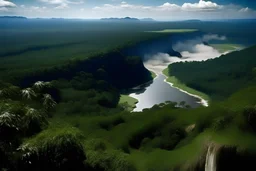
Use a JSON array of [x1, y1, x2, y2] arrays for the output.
[[130, 43, 240, 112]]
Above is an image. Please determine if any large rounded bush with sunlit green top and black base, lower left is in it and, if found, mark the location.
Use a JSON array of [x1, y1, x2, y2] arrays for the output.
[[19, 128, 86, 170]]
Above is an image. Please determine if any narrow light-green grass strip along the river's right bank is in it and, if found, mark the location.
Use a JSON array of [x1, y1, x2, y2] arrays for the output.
[[163, 68, 210, 101]]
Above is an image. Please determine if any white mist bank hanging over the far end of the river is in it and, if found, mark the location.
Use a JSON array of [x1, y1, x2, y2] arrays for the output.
[[144, 34, 226, 74]]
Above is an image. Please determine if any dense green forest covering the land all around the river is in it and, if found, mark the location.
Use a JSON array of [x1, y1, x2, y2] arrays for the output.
[[0, 21, 256, 171]]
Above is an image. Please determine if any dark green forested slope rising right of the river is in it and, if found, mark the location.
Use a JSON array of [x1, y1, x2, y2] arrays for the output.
[[169, 46, 256, 99]]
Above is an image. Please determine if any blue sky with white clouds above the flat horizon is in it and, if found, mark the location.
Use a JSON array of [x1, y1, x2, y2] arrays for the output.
[[0, 0, 256, 20]]
